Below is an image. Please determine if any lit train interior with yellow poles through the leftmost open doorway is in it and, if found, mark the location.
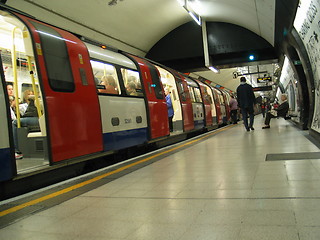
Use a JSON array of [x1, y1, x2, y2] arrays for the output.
[[0, 11, 49, 173]]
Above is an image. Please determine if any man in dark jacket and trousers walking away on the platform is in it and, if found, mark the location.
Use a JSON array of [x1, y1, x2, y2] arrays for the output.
[[237, 77, 256, 132]]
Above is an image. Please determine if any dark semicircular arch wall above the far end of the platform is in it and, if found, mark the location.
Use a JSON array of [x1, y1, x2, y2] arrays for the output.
[[146, 21, 277, 72]]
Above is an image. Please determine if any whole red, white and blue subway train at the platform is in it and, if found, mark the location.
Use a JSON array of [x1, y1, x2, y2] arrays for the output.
[[0, 5, 231, 198]]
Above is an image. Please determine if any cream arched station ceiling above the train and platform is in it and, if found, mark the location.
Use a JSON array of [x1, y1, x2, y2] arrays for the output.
[[6, 0, 294, 90]]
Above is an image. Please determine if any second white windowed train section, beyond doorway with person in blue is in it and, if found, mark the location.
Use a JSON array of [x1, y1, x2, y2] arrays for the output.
[[186, 78, 205, 129]]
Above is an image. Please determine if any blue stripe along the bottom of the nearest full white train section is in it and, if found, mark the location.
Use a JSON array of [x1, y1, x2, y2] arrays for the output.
[[103, 128, 148, 151]]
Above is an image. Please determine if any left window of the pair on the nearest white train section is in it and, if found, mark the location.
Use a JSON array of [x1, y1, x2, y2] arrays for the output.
[[90, 60, 121, 95]]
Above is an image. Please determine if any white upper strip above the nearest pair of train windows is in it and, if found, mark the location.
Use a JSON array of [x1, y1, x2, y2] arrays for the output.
[[85, 43, 137, 69]]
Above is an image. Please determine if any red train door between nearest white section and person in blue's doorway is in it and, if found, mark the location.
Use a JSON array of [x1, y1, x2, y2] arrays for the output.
[[126, 56, 169, 139]]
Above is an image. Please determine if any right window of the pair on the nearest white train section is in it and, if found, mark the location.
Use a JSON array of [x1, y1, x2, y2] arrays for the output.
[[121, 68, 143, 97]]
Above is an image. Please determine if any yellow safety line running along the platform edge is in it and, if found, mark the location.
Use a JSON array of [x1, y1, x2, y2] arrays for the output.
[[0, 125, 233, 217]]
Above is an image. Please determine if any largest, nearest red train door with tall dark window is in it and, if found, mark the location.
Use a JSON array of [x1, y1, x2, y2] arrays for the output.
[[16, 14, 103, 163]]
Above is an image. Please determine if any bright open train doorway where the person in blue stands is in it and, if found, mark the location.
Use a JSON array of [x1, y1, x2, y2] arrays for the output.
[[156, 66, 183, 133]]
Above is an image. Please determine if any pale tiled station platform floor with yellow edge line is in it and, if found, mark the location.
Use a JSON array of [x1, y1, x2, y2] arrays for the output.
[[0, 115, 320, 240]]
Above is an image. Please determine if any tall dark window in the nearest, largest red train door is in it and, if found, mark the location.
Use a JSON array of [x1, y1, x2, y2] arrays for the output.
[[30, 21, 75, 92]]
